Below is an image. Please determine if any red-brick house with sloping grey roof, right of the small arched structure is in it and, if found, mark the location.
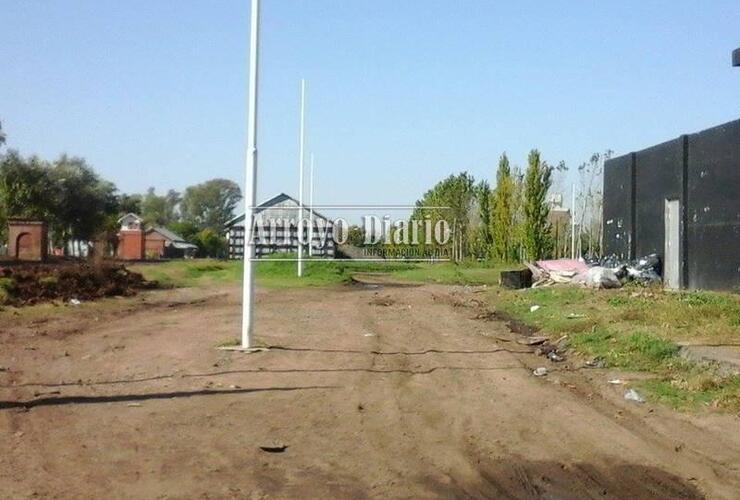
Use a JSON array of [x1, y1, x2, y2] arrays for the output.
[[117, 214, 198, 260]]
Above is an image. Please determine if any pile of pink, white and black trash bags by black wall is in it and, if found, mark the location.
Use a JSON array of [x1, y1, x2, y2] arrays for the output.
[[527, 254, 661, 288]]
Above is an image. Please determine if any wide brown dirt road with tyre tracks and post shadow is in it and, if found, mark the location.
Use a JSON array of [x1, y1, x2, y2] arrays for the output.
[[0, 285, 740, 499]]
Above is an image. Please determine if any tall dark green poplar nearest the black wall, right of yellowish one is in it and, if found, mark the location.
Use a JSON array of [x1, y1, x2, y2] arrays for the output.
[[522, 149, 552, 260]]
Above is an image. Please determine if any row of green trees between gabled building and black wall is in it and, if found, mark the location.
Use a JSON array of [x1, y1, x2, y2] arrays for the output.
[[411, 149, 604, 261]]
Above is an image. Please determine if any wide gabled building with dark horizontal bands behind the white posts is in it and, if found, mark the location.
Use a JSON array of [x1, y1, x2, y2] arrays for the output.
[[225, 193, 336, 260]]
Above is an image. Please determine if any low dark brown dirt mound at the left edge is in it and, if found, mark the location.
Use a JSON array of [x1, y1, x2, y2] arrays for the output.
[[0, 263, 153, 305]]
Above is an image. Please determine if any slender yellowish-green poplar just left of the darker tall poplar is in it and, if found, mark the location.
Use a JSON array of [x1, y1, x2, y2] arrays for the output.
[[491, 153, 515, 261]]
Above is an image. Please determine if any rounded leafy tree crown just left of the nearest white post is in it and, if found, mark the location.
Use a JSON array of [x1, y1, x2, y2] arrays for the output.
[[181, 179, 242, 233]]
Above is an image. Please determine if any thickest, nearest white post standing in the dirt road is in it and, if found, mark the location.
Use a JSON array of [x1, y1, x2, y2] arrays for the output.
[[242, 0, 260, 349]]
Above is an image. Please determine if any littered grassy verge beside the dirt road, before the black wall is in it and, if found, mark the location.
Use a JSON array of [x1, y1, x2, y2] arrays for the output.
[[492, 287, 740, 414]]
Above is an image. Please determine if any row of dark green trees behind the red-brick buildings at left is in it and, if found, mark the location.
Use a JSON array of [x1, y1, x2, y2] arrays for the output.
[[0, 129, 241, 256]]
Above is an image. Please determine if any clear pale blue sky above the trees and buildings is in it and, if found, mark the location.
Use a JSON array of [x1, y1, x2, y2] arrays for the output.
[[0, 0, 740, 211]]
